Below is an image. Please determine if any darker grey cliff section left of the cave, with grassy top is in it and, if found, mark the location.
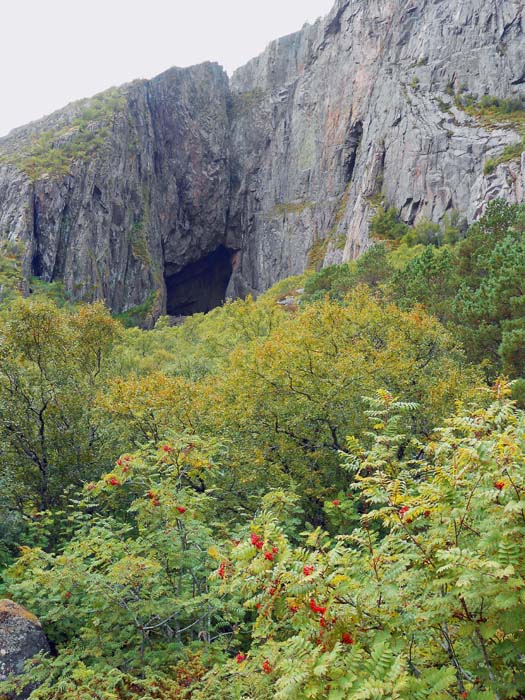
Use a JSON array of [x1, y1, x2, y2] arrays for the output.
[[0, 64, 230, 315]]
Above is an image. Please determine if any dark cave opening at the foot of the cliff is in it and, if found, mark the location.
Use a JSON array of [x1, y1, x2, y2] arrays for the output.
[[165, 246, 234, 316]]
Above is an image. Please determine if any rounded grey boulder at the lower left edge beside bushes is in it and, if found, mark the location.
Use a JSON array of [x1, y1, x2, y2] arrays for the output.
[[0, 600, 49, 699]]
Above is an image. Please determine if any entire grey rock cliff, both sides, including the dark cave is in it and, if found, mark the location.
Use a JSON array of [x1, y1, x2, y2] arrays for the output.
[[0, 0, 525, 317]]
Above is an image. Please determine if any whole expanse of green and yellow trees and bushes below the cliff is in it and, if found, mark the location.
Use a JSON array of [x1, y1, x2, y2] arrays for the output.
[[0, 203, 525, 700]]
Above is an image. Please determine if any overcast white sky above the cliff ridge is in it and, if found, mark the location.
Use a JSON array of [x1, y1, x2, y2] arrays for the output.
[[0, 0, 334, 136]]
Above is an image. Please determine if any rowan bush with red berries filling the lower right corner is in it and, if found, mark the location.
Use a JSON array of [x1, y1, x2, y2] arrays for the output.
[[197, 385, 525, 700]]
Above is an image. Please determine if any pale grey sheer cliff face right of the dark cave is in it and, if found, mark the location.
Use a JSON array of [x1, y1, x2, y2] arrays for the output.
[[227, 0, 525, 290]]
